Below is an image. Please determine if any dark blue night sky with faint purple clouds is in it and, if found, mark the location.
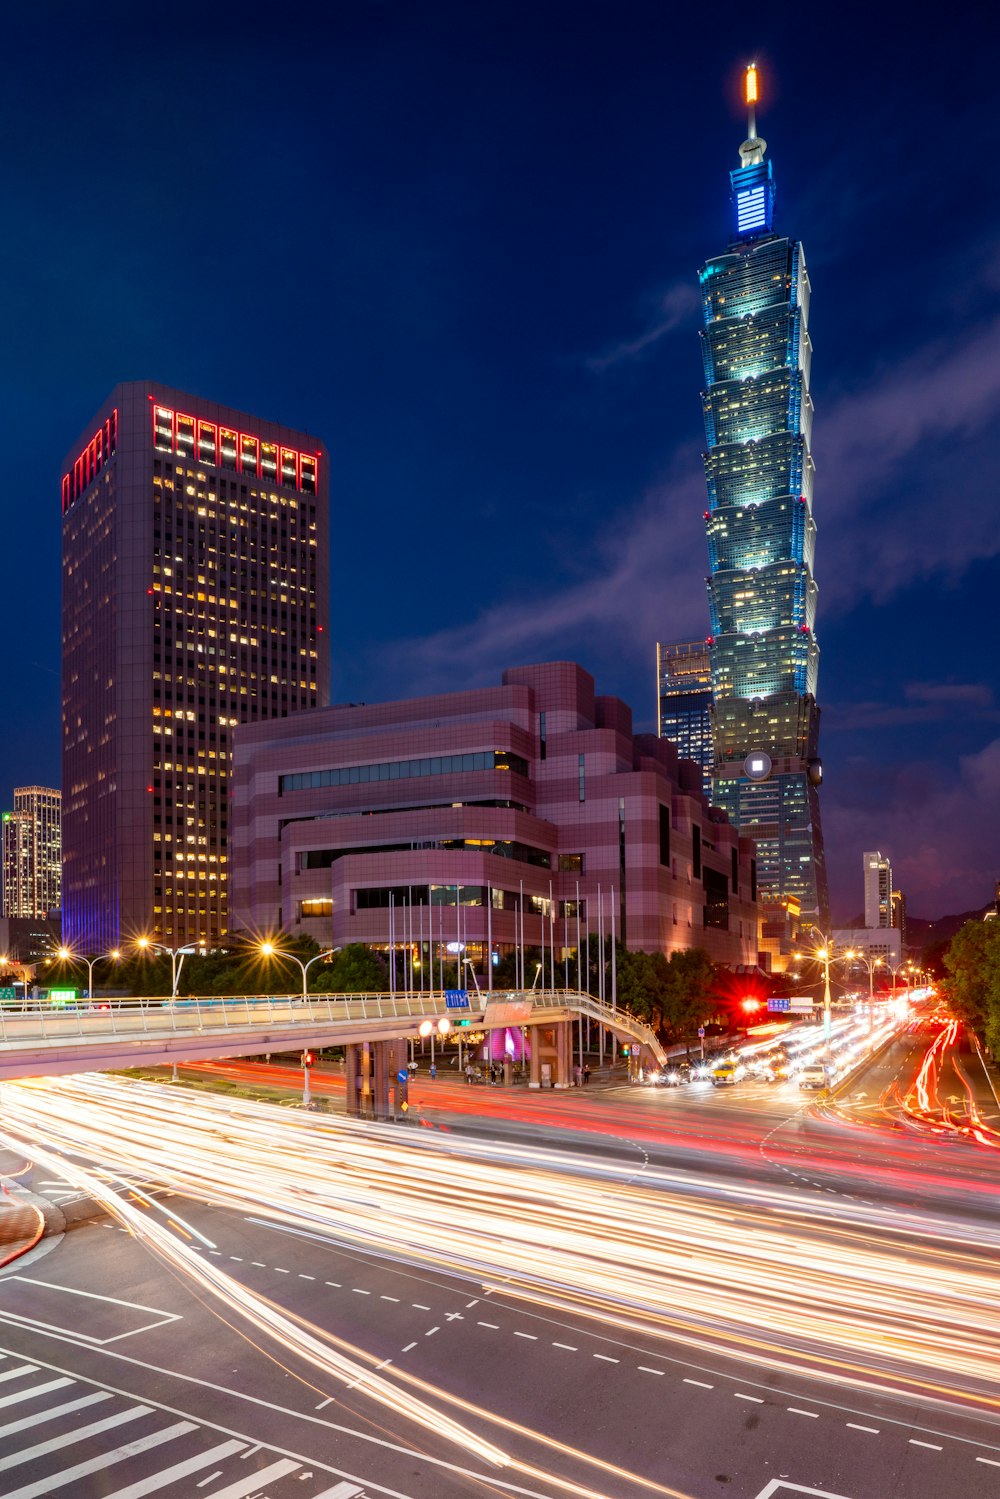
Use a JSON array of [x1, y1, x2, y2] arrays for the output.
[[0, 0, 1000, 922]]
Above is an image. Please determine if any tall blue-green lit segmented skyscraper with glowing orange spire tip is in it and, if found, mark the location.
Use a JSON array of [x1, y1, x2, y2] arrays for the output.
[[700, 67, 828, 935]]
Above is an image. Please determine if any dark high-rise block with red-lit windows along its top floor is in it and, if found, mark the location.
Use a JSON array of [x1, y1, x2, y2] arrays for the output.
[[61, 381, 330, 952]]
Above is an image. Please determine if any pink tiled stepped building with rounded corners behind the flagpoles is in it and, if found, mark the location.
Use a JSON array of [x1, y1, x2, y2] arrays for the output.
[[229, 661, 757, 965]]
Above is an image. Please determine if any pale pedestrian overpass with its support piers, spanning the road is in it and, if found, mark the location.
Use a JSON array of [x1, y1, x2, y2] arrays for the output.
[[0, 989, 667, 1118]]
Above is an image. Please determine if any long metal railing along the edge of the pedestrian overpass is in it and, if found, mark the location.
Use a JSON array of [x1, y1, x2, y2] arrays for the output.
[[0, 989, 666, 1064]]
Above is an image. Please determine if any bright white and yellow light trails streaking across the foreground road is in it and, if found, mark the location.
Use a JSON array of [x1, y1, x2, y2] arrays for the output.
[[4, 1076, 1000, 1439]]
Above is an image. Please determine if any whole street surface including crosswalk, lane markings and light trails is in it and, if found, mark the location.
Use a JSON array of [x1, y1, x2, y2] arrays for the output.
[[0, 1034, 1000, 1499]]
